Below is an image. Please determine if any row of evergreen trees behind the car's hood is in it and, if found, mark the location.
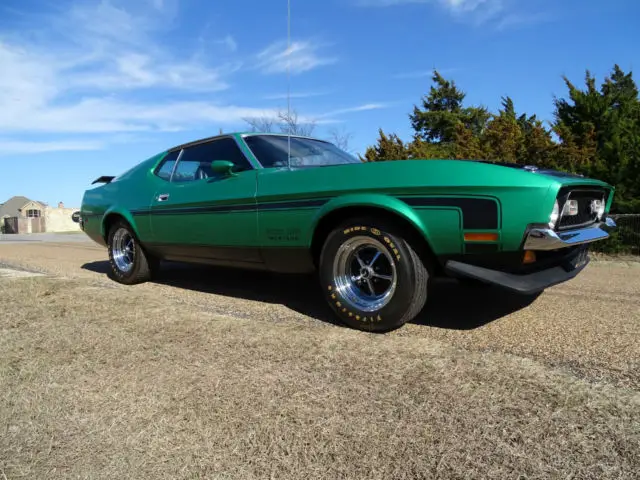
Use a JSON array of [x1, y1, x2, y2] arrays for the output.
[[363, 65, 640, 213]]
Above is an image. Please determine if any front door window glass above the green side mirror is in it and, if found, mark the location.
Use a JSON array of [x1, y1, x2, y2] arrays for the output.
[[172, 138, 252, 182]]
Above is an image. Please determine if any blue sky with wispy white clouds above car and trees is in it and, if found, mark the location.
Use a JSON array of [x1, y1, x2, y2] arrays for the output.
[[0, 0, 640, 207]]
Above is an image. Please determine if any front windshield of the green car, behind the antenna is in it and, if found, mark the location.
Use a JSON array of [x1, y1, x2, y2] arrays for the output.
[[244, 135, 360, 168]]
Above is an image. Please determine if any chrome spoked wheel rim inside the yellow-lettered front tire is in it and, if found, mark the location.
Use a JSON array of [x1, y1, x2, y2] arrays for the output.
[[333, 236, 398, 312]]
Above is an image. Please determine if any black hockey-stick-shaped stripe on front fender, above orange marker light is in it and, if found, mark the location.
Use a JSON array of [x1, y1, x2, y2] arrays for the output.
[[398, 197, 499, 230]]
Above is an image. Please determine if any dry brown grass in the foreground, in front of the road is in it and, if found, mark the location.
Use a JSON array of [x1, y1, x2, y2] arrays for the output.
[[0, 278, 640, 480]]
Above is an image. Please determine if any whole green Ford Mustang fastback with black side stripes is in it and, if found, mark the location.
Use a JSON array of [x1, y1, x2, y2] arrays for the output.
[[79, 133, 615, 331]]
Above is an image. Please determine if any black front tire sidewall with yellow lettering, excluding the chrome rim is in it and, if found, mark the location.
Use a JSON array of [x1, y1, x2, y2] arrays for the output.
[[319, 221, 415, 331]]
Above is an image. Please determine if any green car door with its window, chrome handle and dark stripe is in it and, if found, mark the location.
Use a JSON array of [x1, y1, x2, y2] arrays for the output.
[[151, 137, 261, 263]]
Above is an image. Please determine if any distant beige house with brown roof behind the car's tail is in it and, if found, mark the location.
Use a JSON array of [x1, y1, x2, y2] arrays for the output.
[[0, 196, 80, 233]]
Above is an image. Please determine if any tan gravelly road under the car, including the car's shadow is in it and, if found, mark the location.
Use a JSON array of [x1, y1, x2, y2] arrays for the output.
[[0, 242, 640, 388]]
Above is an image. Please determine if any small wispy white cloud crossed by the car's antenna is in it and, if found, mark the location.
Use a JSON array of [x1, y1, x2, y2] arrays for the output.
[[257, 41, 337, 74]]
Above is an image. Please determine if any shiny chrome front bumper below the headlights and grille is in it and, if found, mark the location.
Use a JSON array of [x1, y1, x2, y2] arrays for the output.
[[524, 217, 616, 250]]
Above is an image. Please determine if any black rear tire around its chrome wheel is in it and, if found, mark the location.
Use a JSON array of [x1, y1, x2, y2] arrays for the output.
[[107, 220, 160, 285]]
